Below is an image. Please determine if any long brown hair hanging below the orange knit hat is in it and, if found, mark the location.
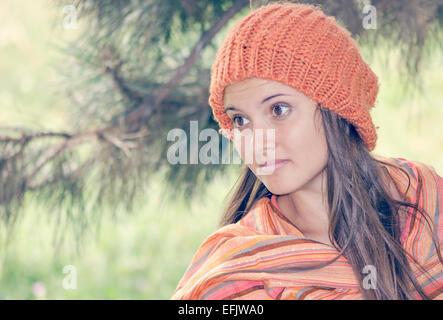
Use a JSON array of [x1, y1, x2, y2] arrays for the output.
[[220, 104, 443, 300]]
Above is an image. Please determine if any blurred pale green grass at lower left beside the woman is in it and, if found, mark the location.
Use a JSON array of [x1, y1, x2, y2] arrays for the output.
[[0, 170, 229, 299]]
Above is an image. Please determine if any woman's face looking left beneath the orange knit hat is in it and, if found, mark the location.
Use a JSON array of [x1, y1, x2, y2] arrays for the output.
[[224, 78, 328, 195]]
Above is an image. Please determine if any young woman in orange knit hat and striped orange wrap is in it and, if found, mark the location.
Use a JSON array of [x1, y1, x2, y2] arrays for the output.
[[172, 3, 443, 299]]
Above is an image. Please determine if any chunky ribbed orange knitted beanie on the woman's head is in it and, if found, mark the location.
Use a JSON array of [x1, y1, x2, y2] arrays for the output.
[[209, 3, 378, 151]]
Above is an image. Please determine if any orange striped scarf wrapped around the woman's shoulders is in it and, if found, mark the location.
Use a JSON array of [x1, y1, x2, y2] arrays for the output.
[[171, 156, 443, 300]]
